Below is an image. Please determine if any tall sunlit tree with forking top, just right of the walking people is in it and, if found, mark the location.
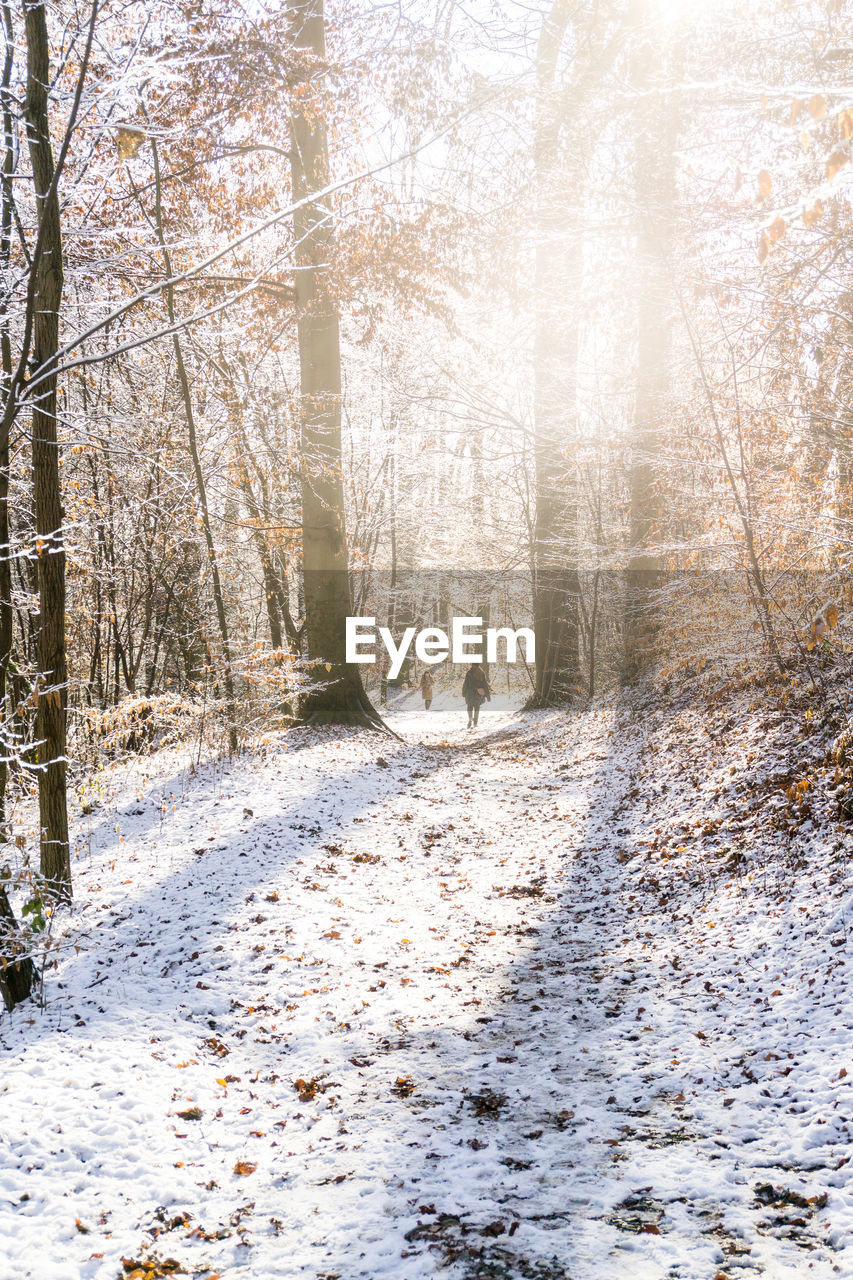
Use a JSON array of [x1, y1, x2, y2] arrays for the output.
[[522, 0, 619, 707]]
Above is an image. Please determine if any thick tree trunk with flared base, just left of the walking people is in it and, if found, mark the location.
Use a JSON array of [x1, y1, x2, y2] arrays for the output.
[[288, 0, 382, 726]]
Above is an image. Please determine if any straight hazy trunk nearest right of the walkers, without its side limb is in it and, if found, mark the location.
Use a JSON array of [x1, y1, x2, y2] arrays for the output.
[[529, 0, 580, 707]]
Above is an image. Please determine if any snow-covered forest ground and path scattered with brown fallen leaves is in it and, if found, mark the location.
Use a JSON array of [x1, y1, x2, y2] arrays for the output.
[[0, 692, 853, 1280]]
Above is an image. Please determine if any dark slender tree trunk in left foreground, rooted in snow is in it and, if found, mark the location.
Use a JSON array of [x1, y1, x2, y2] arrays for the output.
[[23, 0, 70, 899]]
